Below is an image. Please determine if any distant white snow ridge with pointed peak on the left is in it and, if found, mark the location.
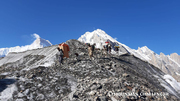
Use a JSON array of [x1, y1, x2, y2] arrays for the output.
[[0, 34, 52, 57]]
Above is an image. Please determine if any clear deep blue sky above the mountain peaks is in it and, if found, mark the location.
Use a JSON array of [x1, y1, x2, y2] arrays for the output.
[[0, 0, 180, 55]]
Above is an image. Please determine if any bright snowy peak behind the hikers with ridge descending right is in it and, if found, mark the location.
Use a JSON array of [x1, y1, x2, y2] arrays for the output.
[[78, 29, 180, 81]]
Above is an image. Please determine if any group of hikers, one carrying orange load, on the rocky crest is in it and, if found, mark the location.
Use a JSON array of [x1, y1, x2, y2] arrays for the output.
[[57, 41, 119, 65]]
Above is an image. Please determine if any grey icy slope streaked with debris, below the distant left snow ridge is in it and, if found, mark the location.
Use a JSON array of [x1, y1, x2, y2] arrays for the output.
[[0, 45, 58, 69]]
